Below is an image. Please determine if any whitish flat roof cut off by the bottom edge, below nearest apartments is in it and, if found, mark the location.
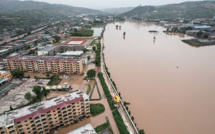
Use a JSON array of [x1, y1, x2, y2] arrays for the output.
[[67, 124, 97, 134]]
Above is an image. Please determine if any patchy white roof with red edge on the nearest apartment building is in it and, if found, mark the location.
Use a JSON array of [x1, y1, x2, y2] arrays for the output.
[[0, 89, 89, 127]]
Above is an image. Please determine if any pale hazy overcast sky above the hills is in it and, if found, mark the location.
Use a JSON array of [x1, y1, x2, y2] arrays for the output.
[[30, 0, 199, 9]]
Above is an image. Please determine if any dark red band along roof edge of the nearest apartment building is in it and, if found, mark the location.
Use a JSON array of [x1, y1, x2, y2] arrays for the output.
[[14, 97, 83, 123]]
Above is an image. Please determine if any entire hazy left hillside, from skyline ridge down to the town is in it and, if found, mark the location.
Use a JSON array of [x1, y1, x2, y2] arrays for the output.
[[0, 0, 103, 34]]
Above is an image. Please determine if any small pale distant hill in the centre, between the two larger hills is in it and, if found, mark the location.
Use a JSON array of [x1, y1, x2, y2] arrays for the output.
[[102, 7, 134, 14]]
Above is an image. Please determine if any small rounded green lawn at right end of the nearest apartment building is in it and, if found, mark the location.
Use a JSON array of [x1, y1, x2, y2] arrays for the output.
[[90, 103, 105, 116]]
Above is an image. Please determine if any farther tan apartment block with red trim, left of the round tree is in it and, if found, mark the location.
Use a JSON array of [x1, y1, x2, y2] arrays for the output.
[[4, 56, 83, 74]]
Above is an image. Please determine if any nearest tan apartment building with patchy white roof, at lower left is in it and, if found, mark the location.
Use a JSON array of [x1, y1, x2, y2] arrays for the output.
[[0, 90, 90, 134]]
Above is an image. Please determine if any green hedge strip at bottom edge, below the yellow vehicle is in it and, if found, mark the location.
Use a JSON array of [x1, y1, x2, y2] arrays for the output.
[[112, 109, 129, 134]]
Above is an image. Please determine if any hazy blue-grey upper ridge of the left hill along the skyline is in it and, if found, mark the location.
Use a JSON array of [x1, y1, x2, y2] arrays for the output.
[[0, 0, 102, 15]]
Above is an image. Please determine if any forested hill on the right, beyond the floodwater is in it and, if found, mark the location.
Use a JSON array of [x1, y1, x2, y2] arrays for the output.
[[121, 1, 215, 19]]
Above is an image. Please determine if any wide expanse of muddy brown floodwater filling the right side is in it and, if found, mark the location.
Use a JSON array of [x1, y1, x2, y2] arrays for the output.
[[104, 22, 215, 134]]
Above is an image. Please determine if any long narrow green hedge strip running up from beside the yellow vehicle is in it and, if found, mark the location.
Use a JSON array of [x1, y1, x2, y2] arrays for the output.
[[98, 72, 115, 110]]
